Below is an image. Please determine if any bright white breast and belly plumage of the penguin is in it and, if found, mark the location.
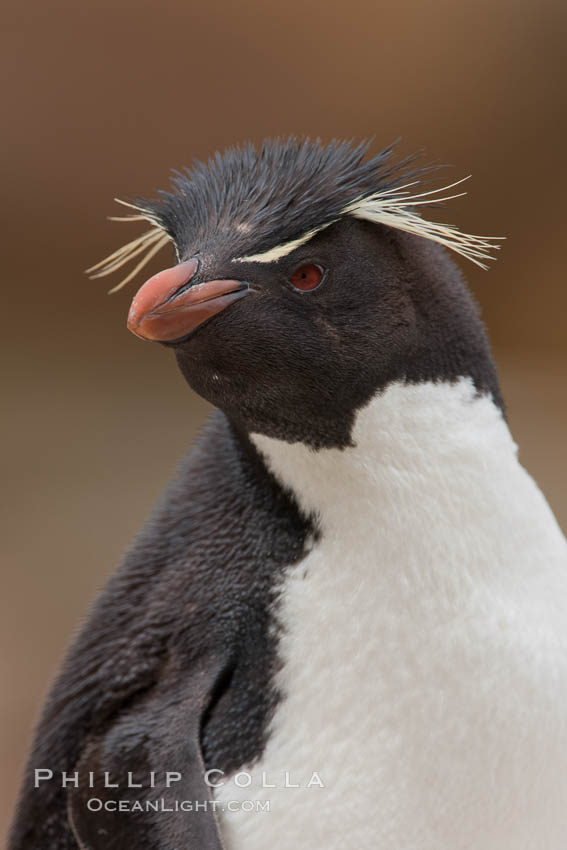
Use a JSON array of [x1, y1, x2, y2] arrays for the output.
[[216, 380, 567, 850]]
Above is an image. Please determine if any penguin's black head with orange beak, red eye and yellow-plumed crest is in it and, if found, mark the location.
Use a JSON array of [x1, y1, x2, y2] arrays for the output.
[[91, 140, 499, 449]]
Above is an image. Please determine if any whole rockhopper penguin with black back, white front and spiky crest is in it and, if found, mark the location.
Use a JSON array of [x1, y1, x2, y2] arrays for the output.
[[9, 140, 567, 850]]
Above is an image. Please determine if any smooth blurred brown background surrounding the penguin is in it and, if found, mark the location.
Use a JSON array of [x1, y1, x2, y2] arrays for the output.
[[0, 0, 567, 831]]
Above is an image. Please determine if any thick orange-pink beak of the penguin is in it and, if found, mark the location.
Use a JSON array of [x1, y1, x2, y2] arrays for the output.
[[128, 258, 249, 342]]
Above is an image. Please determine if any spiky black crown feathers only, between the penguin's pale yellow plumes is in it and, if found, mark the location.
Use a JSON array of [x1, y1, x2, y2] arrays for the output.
[[135, 137, 422, 258]]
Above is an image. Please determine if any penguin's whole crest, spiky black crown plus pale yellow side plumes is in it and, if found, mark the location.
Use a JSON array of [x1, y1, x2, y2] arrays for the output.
[[88, 137, 501, 292]]
